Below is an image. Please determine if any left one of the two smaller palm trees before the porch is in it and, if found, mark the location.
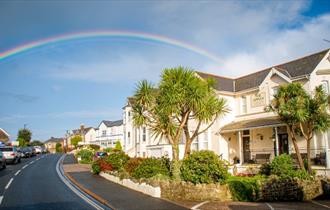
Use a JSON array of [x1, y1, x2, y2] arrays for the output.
[[266, 83, 308, 170]]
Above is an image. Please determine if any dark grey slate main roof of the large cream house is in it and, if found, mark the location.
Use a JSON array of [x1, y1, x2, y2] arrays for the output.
[[196, 49, 329, 92]]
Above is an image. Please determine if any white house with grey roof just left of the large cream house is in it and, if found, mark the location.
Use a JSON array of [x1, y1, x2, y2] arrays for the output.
[[90, 120, 125, 150]]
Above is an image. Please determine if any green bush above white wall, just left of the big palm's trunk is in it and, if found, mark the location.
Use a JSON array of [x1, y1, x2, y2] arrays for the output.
[[132, 158, 170, 179]]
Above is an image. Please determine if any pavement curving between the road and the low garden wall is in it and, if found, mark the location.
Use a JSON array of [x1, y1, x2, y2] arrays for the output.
[[63, 155, 186, 210]]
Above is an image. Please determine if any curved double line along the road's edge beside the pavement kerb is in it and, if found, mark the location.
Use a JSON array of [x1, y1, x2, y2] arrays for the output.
[[56, 155, 104, 210]]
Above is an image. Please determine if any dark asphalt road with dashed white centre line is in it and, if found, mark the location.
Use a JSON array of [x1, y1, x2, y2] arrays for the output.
[[0, 154, 93, 210]]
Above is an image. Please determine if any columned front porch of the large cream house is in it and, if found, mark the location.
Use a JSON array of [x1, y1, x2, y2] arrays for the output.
[[220, 117, 328, 167]]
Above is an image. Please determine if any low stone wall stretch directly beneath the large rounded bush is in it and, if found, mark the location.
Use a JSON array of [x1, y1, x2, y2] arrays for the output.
[[159, 181, 231, 201]]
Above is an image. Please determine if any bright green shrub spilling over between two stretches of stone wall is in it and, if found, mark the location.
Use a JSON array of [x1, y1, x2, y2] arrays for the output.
[[227, 176, 264, 201]]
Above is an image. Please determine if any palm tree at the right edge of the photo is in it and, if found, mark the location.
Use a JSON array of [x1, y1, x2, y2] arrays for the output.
[[299, 86, 330, 173]]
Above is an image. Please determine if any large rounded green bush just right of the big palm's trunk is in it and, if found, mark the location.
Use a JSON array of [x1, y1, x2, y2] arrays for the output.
[[181, 150, 229, 184]]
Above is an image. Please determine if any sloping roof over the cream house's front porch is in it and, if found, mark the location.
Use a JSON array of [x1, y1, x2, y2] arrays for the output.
[[220, 117, 283, 133]]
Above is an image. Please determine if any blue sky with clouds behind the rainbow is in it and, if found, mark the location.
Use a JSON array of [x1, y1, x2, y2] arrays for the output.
[[0, 0, 330, 140]]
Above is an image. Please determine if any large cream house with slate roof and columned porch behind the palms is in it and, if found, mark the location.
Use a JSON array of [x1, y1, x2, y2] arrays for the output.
[[123, 49, 330, 168]]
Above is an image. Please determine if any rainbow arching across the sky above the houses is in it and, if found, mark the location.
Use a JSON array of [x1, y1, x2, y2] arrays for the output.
[[0, 30, 221, 63]]
